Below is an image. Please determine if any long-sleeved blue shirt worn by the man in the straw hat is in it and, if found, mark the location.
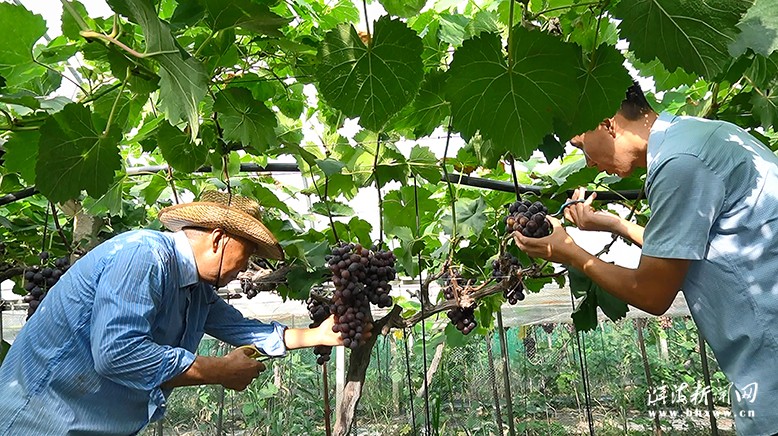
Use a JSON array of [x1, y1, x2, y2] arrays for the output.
[[0, 230, 286, 436]]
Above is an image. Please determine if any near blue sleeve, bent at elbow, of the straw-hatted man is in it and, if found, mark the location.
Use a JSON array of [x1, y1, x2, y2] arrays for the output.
[[90, 246, 195, 420]]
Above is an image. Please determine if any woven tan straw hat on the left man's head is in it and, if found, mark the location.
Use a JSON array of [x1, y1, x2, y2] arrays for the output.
[[159, 191, 284, 260]]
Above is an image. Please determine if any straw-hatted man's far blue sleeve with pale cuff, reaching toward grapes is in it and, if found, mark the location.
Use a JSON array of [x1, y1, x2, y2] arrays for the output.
[[205, 297, 286, 356]]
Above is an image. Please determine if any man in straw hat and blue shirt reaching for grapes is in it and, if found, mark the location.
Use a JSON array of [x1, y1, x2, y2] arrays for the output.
[[0, 191, 341, 436]]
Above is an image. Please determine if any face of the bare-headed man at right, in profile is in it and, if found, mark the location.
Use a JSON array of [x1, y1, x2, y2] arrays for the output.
[[570, 120, 634, 177]]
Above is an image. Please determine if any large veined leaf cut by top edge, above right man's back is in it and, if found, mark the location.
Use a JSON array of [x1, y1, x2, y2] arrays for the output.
[[612, 0, 752, 78]]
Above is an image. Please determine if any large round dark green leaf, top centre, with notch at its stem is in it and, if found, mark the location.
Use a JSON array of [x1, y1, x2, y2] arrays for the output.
[[317, 16, 424, 131]]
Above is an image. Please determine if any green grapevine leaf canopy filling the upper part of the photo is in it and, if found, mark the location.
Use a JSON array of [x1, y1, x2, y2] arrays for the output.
[[0, 0, 778, 328]]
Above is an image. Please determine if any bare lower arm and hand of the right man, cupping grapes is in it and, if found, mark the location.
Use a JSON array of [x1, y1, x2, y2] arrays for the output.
[[514, 219, 690, 315]]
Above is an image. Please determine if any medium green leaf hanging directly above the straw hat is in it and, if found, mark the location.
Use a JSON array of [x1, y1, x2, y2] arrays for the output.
[[213, 88, 278, 153]]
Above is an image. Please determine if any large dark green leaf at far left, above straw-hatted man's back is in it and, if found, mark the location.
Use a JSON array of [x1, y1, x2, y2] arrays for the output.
[[35, 103, 122, 202]]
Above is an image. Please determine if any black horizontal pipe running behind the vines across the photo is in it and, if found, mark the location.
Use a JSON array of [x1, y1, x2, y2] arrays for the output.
[[0, 162, 640, 206]]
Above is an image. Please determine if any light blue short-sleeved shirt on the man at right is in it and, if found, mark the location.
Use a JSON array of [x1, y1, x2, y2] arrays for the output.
[[643, 114, 778, 435]]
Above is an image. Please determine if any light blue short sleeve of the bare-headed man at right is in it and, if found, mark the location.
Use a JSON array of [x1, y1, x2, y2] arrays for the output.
[[643, 154, 726, 260]]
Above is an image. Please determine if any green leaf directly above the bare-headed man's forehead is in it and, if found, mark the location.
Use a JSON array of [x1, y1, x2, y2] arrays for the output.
[[557, 45, 632, 141]]
